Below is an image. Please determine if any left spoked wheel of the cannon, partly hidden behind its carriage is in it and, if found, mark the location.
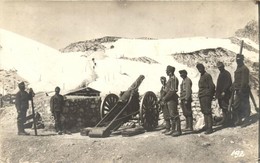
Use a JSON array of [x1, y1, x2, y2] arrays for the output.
[[100, 93, 119, 119]]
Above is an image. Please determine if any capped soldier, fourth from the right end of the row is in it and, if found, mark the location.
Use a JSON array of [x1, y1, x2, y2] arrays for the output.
[[179, 70, 193, 131]]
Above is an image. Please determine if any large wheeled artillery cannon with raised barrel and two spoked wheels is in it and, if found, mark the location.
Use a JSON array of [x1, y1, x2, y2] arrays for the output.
[[88, 75, 159, 137]]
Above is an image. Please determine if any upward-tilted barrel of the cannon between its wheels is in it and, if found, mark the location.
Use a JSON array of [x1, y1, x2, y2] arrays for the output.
[[119, 75, 145, 102]]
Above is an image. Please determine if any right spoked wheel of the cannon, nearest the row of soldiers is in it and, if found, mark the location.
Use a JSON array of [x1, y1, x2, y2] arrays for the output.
[[140, 91, 159, 131]]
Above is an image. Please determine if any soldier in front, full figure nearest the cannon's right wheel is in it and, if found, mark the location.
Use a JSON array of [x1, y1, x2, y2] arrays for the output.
[[161, 66, 181, 136]]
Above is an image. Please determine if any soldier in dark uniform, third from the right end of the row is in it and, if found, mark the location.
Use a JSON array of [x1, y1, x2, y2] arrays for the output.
[[196, 63, 215, 134]]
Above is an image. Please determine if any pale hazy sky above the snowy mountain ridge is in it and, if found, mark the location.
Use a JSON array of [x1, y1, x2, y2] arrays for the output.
[[0, 0, 258, 49]]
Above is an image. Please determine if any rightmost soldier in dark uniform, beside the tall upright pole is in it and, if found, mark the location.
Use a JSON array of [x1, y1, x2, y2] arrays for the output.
[[232, 54, 251, 125]]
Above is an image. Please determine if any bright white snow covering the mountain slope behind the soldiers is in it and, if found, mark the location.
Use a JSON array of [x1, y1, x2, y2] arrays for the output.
[[0, 29, 258, 95]]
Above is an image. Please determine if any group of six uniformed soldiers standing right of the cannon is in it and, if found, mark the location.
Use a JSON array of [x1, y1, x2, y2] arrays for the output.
[[159, 54, 250, 137]]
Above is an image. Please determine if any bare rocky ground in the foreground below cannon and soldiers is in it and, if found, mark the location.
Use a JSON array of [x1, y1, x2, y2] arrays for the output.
[[0, 106, 258, 163]]
